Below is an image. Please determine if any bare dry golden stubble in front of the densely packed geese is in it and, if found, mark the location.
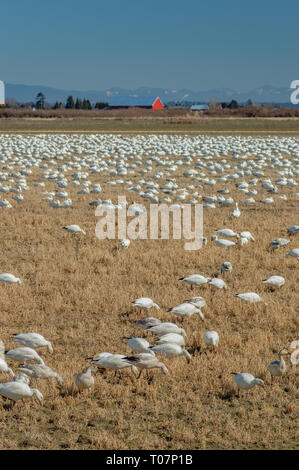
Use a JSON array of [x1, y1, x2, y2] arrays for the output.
[[0, 141, 299, 449]]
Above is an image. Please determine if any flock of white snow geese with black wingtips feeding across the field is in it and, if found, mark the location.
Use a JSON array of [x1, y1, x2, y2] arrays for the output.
[[0, 134, 299, 403]]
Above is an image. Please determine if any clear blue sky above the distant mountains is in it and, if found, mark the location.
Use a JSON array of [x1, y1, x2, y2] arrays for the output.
[[0, 0, 299, 91]]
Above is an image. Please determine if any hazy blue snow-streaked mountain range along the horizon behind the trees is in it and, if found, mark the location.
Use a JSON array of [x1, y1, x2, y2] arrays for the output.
[[5, 83, 292, 106]]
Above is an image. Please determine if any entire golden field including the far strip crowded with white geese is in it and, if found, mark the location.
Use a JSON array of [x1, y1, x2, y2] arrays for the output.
[[0, 131, 299, 450]]
